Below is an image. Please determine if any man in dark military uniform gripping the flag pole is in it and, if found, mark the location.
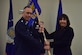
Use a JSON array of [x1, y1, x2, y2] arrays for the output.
[[15, 6, 49, 55]]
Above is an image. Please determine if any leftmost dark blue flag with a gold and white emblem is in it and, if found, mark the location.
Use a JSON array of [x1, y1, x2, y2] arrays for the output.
[[6, 0, 15, 55]]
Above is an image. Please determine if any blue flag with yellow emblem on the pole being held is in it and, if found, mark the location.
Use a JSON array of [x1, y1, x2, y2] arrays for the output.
[[27, 0, 41, 26]]
